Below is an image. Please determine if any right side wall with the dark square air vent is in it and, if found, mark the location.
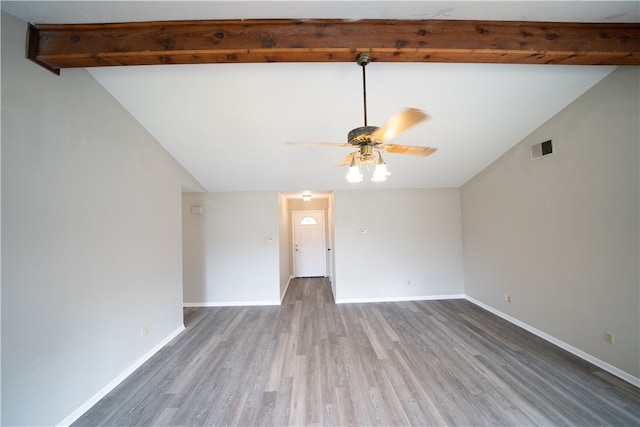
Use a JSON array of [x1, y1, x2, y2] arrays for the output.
[[462, 67, 640, 378]]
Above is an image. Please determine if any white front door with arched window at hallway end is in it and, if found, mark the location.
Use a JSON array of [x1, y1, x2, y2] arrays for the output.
[[292, 211, 327, 277]]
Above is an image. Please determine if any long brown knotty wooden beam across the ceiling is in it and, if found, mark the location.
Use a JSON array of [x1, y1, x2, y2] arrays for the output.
[[27, 20, 640, 72]]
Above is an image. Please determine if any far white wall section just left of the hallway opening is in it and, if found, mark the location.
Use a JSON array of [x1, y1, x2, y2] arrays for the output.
[[183, 192, 280, 305]]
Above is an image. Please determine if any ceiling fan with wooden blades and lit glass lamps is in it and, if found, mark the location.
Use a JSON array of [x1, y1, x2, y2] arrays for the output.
[[287, 52, 437, 182]]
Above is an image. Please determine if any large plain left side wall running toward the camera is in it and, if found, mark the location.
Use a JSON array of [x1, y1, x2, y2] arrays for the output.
[[2, 13, 204, 425]]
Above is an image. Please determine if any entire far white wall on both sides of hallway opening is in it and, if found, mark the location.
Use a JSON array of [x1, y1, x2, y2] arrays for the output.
[[183, 189, 463, 306]]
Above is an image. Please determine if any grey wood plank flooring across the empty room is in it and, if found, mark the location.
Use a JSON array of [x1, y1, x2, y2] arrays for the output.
[[74, 279, 640, 426]]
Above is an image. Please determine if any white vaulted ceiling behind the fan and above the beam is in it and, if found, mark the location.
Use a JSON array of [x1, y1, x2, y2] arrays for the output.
[[2, 0, 640, 193]]
